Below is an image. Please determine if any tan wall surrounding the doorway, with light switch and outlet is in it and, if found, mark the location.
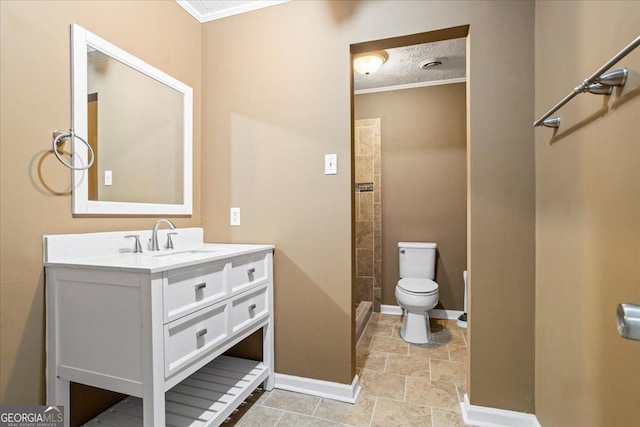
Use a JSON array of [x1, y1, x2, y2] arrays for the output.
[[202, 1, 534, 411]]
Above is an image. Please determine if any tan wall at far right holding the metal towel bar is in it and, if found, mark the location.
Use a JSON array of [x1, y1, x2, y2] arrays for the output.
[[535, 1, 640, 427]]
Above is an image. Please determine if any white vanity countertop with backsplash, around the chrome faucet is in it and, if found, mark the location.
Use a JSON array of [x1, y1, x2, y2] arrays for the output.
[[43, 228, 274, 273]]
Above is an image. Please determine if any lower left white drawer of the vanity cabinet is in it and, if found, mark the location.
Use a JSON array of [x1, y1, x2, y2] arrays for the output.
[[164, 303, 229, 377]]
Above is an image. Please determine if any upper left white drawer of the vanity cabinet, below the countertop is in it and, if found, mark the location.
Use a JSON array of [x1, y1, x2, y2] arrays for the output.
[[163, 262, 227, 323]]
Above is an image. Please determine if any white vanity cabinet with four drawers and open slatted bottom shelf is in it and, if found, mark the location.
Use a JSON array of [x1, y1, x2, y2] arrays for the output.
[[45, 233, 274, 426]]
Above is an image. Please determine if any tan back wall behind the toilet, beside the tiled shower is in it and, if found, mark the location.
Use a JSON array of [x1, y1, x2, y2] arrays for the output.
[[354, 83, 467, 310]]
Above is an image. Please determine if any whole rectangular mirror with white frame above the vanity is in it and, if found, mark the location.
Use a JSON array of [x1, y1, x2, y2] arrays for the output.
[[71, 24, 193, 215]]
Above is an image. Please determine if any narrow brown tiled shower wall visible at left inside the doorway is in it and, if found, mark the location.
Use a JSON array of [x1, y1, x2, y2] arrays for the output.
[[355, 118, 382, 312]]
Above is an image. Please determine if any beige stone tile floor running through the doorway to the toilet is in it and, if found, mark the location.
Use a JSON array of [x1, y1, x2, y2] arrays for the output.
[[223, 313, 467, 427]]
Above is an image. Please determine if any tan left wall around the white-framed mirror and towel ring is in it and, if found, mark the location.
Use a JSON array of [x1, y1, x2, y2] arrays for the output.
[[0, 1, 201, 420]]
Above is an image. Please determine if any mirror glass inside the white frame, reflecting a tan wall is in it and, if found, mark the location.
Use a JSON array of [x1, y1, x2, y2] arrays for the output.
[[87, 48, 184, 204]]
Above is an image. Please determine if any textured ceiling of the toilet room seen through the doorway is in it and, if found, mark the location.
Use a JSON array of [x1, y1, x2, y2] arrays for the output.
[[354, 38, 467, 91]]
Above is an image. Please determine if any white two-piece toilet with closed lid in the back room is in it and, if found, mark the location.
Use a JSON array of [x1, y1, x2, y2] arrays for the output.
[[396, 242, 438, 344]]
